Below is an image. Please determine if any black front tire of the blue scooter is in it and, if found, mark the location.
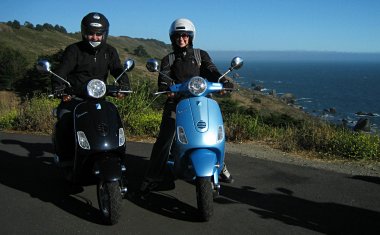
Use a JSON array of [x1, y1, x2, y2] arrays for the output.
[[196, 177, 214, 221]]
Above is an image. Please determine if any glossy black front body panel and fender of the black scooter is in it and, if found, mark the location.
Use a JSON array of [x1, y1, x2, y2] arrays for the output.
[[73, 100, 126, 181]]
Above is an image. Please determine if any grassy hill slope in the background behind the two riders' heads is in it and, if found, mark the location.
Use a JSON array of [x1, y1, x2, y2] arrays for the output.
[[0, 23, 171, 67]]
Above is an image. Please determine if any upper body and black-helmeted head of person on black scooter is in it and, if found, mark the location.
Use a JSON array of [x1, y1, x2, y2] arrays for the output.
[[52, 12, 129, 96]]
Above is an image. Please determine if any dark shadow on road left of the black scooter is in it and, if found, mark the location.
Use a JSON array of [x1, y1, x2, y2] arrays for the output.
[[0, 139, 102, 224]]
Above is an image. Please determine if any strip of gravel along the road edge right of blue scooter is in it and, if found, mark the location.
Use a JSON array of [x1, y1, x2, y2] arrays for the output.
[[226, 142, 380, 177]]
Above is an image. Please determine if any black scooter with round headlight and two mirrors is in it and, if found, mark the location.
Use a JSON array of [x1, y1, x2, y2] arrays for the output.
[[37, 59, 135, 224]]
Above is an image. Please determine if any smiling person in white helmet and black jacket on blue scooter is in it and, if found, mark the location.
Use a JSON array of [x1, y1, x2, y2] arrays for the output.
[[140, 19, 233, 195]]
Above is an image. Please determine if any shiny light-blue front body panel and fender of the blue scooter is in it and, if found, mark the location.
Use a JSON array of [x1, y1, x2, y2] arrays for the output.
[[172, 97, 225, 178]]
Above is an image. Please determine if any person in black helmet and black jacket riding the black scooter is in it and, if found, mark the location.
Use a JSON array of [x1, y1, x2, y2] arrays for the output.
[[52, 12, 129, 161]]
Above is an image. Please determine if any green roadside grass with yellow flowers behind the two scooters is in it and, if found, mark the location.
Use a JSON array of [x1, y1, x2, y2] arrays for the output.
[[0, 89, 380, 162]]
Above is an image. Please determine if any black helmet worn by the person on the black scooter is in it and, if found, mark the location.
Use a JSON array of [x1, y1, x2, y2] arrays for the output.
[[81, 12, 110, 46]]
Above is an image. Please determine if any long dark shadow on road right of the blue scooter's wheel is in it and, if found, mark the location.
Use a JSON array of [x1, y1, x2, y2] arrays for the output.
[[218, 185, 380, 234]]
